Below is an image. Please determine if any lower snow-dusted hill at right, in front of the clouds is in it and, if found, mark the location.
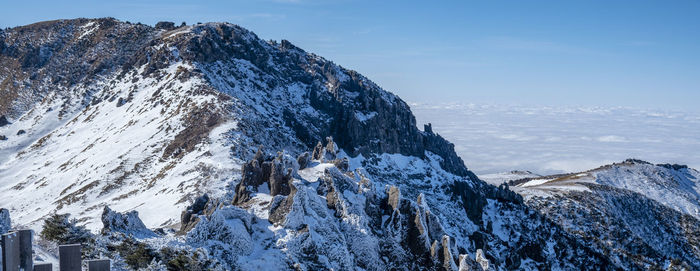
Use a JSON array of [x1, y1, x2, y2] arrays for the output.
[[510, 159, 700, 270]]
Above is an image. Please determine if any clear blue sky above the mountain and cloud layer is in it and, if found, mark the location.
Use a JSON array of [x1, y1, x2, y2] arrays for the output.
[[0, 0, 700, 110]]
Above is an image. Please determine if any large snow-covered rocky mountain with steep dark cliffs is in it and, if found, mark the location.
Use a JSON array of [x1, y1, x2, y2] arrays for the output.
[[0, 18, 697, 270]]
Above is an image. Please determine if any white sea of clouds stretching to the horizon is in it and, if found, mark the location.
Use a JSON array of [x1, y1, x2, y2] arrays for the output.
[[410, 103, 700, 174]]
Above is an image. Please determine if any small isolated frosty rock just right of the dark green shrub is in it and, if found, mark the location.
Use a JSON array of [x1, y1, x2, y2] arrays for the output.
[[102, 206, 155, 238]]
